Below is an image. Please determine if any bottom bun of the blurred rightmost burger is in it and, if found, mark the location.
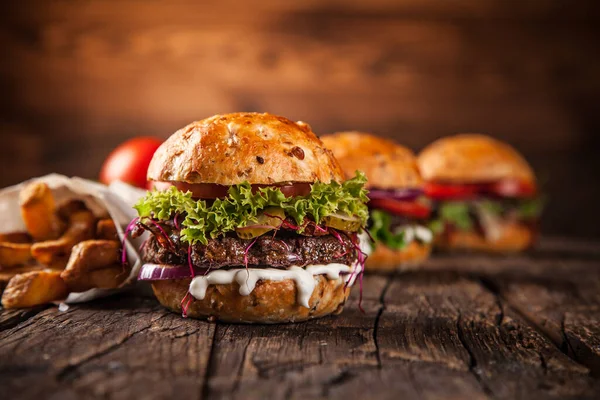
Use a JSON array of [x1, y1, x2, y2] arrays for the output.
[[435, 222, 536, 253]]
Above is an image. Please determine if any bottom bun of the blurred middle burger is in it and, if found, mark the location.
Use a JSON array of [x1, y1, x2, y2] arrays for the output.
[[365, 240, 431, 272]]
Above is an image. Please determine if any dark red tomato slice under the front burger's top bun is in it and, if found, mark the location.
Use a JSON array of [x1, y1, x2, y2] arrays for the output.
[[150, 182, 310, 199]]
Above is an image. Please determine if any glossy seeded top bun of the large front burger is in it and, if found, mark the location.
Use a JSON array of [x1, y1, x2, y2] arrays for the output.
[[148, 113, 343, 185]]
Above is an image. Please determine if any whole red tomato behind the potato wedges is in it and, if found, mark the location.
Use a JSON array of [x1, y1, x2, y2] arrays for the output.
[[100, 137, 162, 188]]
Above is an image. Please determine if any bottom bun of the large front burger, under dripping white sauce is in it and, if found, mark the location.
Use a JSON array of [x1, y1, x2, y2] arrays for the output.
[[152, 275, 350, 324]]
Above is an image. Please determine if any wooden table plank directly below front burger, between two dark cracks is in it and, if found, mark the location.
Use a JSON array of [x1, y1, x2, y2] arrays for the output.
[[205, 277, 387, 398]]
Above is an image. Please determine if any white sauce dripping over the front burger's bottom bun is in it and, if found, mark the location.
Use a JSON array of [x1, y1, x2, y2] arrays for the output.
[[189, 263, 361, 308]]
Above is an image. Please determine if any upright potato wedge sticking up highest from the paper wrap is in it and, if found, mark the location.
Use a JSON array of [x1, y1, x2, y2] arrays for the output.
[[19, 182, 63, 241]]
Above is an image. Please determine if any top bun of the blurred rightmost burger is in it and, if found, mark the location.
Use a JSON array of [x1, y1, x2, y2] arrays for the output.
[[418, 133, 535, 183]]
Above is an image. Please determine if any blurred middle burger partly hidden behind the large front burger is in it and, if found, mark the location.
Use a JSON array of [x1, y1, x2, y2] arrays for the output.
[[322, 132, 433, 271]]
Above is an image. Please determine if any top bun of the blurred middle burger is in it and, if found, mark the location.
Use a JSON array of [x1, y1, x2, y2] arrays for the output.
[[321, 132, 422, 189]]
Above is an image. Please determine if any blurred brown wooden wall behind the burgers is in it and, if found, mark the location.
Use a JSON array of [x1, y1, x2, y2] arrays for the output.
[[0, 0, 600, 236]]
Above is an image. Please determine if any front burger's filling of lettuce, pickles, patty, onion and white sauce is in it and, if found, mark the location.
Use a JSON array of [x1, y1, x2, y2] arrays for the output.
[[130, 173, 368, 314]]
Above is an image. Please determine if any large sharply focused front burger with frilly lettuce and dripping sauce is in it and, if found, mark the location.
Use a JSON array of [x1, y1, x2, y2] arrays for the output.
[[131, 113, 368, 323]]
